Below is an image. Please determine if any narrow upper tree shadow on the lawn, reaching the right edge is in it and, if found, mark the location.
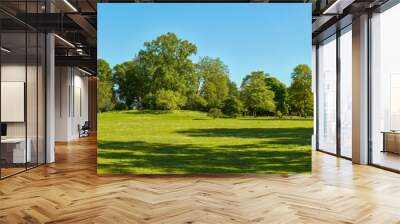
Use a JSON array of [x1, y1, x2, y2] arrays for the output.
[[177, 127, 312, 146]]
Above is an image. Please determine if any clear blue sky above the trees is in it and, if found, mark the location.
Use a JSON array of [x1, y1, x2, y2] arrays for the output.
[[97, 3, 311, 85]]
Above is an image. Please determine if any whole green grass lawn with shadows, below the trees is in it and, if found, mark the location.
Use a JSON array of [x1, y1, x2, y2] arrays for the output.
[[97, 111, 313, 174]]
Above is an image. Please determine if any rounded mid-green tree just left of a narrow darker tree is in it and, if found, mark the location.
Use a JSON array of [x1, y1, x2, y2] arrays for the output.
[[241, 71, 276, 116]]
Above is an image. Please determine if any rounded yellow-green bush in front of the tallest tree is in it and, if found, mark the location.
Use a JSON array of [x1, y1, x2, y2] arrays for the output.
[[155, 89, 186, 110]]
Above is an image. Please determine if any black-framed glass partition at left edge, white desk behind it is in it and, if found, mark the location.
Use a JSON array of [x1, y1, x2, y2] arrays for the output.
[[0, 1, 46, 178]]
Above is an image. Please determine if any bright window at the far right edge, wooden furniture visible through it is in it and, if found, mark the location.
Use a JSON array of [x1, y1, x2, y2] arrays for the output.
[[370, 4, 400, 170]]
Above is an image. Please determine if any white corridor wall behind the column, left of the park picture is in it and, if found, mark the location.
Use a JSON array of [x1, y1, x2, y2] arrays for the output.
[[55, 67, 88, 141]]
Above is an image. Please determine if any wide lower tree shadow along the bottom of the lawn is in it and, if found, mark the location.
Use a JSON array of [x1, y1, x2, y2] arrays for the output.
[[98, 141, 311, 174]]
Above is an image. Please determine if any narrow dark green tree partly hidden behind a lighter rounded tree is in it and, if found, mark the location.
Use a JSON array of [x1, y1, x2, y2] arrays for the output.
[[266, 76, 289, 115]]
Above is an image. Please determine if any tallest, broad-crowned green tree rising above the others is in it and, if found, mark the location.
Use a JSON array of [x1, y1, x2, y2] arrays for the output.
[[136, 33, 198, 102]]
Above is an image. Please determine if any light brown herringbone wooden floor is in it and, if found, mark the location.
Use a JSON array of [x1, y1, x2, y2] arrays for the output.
[[0, 138, 400, 224]]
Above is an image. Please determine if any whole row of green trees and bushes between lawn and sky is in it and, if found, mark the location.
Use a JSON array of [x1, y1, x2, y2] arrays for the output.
[[97, 33, 313, 117]]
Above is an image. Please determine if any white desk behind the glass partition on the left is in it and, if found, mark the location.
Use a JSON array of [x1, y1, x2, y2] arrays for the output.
[[1, 138, 32, 163]]
